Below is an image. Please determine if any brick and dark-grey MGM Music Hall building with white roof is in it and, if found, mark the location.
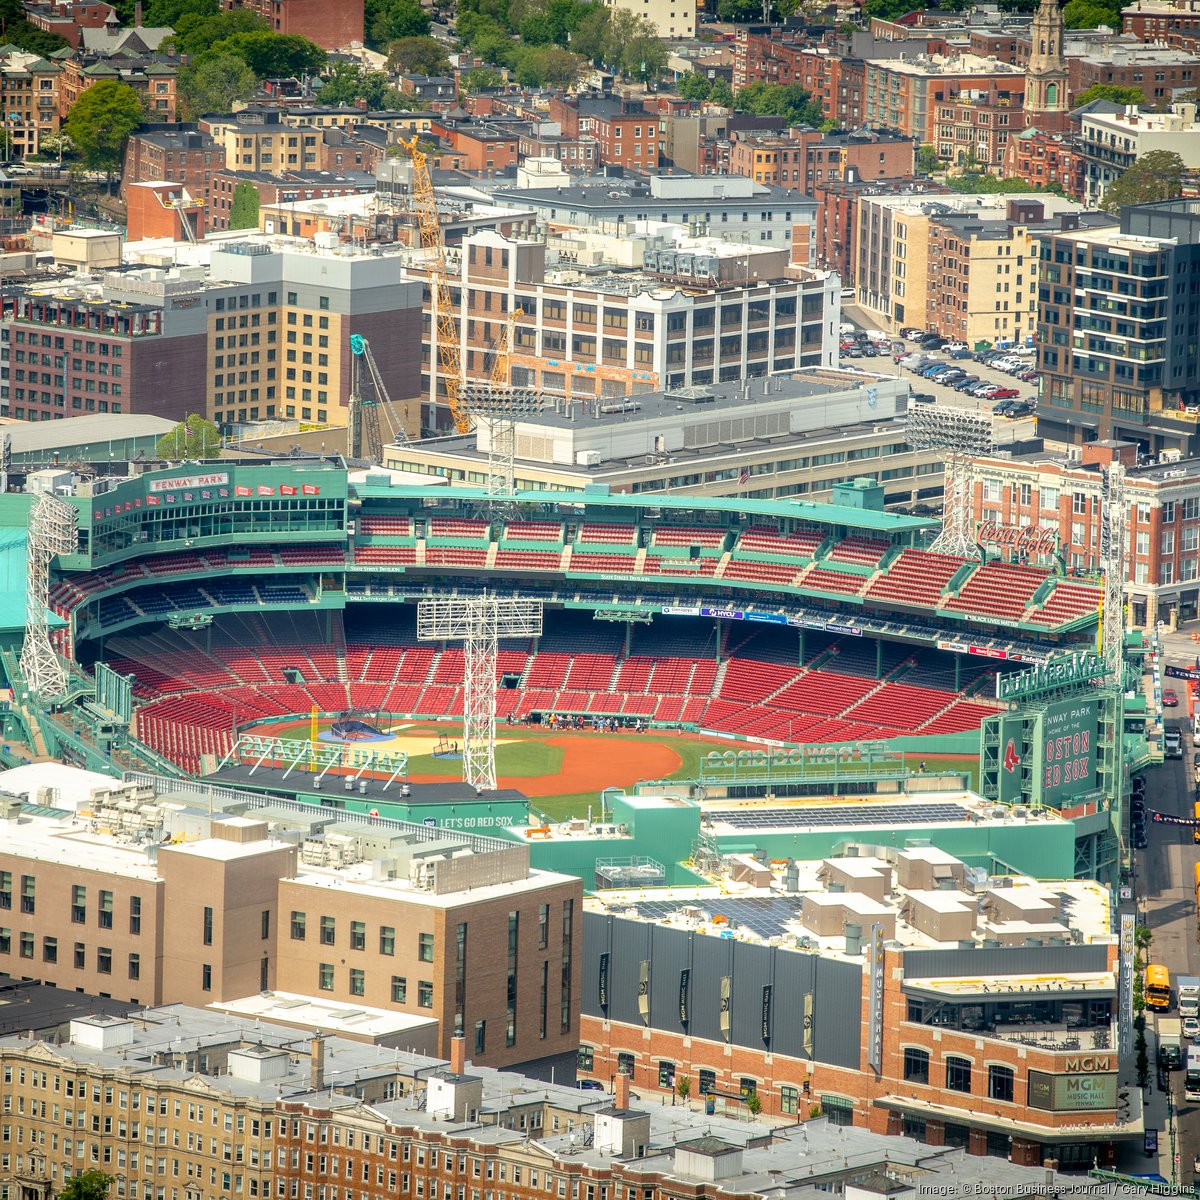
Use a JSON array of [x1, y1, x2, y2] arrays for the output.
[[580, 854, 1130, 1170]]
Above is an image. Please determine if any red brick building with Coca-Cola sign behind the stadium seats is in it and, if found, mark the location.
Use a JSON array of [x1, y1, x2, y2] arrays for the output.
[[967, 442, 1200, 629]]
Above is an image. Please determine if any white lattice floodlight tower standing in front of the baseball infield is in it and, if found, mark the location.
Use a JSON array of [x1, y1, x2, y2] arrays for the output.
[[416, 593, 542, 793]]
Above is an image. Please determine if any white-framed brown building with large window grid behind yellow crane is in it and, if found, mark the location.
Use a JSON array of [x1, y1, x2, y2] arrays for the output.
[[414, 228, 840, 428]]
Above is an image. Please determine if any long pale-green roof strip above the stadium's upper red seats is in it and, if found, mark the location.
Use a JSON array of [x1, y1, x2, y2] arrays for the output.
[[355, 484, 938, 533]]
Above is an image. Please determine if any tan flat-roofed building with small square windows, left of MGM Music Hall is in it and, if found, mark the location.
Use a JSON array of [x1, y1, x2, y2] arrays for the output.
[[0, 785, 582, 1080]]
